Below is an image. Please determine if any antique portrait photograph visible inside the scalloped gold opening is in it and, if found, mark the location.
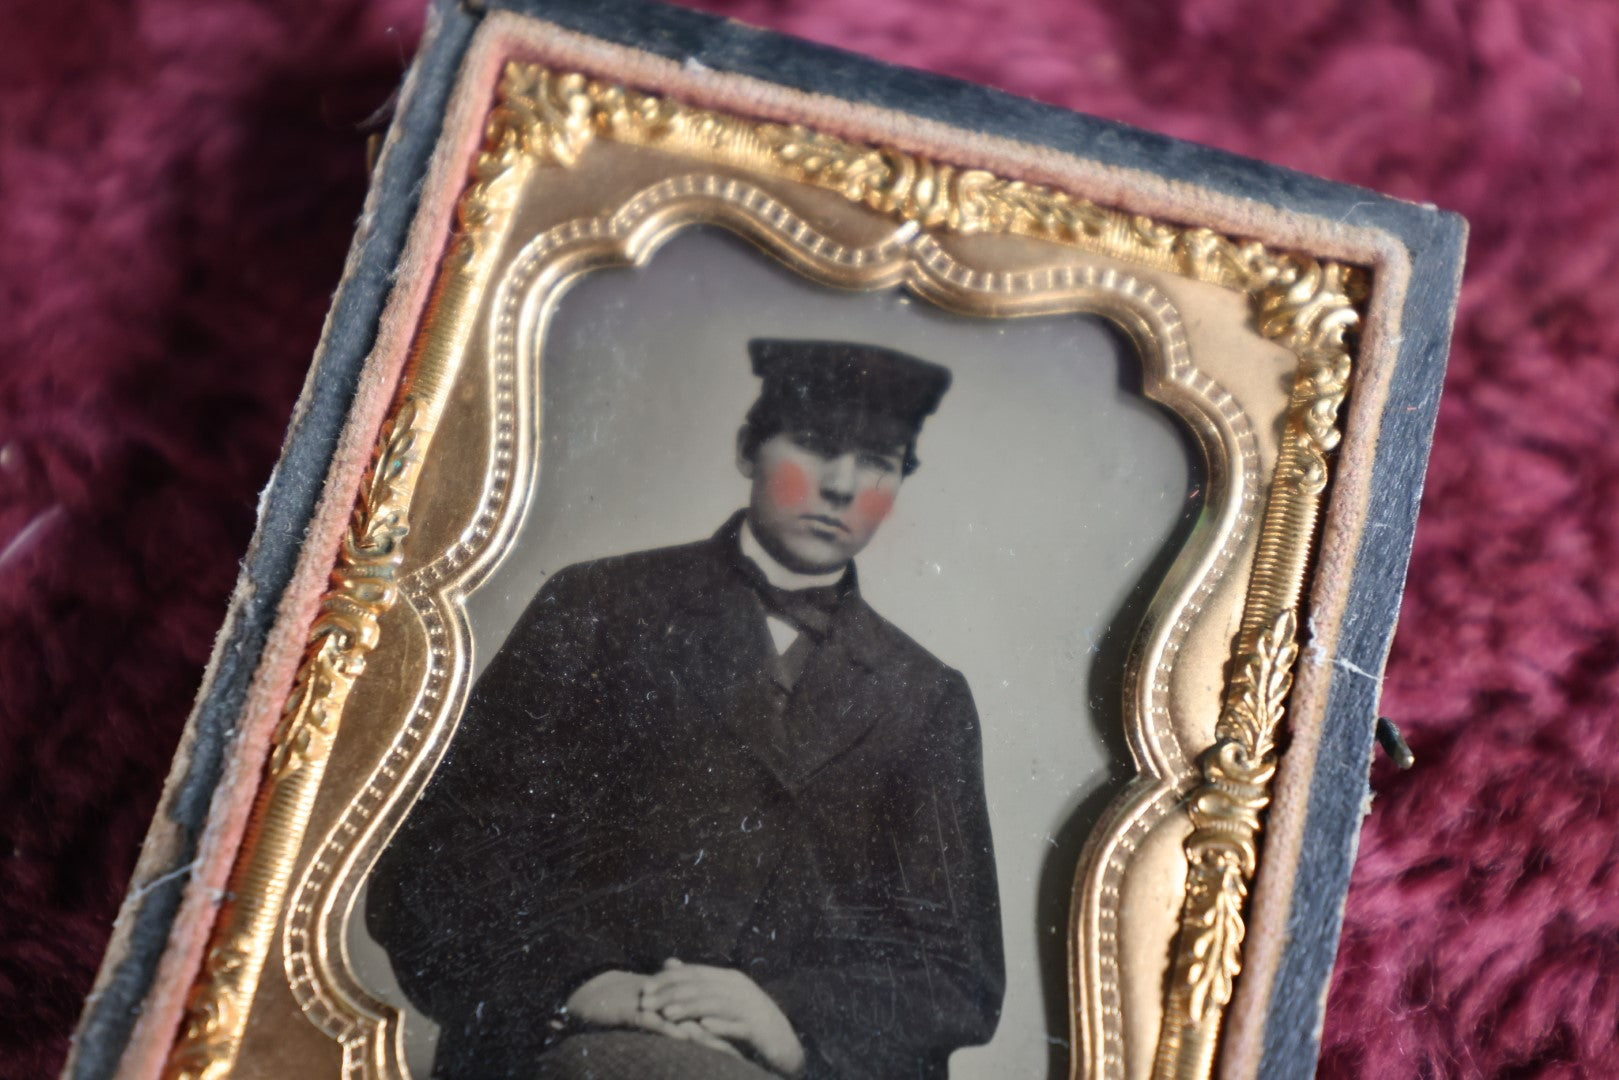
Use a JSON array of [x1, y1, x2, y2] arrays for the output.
[[351, 228, 1200, 1077]]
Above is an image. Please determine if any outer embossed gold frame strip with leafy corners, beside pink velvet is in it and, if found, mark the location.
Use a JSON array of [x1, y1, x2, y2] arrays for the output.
[[165, 62, 1365, 1080]]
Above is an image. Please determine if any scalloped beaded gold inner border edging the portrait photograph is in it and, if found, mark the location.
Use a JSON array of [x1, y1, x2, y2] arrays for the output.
[[282, 173, 1260, 1080]]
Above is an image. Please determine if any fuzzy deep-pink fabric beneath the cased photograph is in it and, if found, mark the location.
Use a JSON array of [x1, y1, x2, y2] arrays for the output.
[[0, 0, 1619, 1078]]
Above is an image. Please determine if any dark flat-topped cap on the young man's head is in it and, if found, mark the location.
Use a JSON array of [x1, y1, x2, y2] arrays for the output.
[[748, 338, 950, 442]]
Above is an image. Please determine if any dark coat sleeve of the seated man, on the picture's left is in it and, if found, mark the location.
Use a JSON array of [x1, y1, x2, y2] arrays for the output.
[[366, 568, 618, 1040]]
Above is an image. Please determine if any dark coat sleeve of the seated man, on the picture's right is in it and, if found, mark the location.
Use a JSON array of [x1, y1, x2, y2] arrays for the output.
[[764, 670, 1005, 1080]]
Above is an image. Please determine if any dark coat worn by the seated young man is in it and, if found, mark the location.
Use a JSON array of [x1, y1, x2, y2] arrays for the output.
[[366, 517, 1005, 1080]]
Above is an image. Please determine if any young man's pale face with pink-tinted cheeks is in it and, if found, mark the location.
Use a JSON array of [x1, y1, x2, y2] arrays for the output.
[[737, 431, 905, 573]]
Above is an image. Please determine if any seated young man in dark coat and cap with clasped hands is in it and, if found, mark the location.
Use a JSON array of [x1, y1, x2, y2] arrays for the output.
[[366, 340, 1005, 1080]]
